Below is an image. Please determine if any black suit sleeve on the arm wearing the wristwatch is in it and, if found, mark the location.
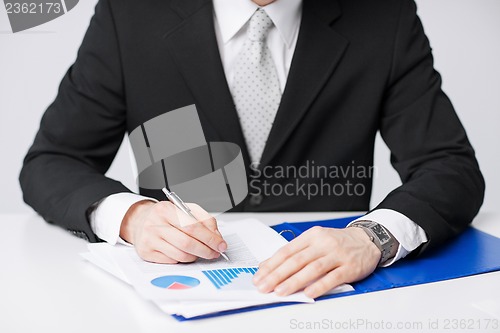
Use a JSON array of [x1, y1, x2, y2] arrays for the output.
[[377, 0, 485, 253]]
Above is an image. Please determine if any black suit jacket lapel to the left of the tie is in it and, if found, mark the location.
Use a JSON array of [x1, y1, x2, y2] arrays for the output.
[[165, 0, 250, 166]]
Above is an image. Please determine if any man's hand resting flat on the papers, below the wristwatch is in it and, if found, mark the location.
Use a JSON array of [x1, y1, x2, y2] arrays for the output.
[[254, 227, 381, 298]]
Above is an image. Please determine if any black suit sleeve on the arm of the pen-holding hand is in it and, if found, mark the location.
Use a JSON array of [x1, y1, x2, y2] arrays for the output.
[[20, 0, 130, 241]]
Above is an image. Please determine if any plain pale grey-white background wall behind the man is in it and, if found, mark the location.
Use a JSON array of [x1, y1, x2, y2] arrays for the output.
[[0, 0, 500, 213]]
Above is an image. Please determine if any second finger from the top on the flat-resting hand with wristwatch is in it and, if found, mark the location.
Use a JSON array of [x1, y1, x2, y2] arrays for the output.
[[256, 247, 318, 293]]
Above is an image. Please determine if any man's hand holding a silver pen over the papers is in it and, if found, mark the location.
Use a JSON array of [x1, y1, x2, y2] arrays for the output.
[[120, 200, 227, 264]]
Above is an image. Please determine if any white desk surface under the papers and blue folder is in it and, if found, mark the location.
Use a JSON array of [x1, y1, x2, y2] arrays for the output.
[[0, 213, 500, 333]]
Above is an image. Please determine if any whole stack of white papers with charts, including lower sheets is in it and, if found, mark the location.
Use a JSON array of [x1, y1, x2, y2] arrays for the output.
[[80, 219, 353, 317]]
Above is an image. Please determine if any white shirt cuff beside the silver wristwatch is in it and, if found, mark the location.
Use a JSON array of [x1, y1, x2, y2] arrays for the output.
[[348, 208, 427, 267]]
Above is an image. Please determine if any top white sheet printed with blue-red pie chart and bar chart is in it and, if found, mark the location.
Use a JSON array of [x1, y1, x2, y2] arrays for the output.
[[113, 219, 313, 302]]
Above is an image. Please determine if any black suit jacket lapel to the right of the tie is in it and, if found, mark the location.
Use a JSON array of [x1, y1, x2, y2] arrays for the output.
[[260, 0, 348, 167]]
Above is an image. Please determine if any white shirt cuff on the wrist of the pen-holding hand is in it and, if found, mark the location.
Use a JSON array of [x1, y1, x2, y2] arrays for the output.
[[89, 193, 157, 245]]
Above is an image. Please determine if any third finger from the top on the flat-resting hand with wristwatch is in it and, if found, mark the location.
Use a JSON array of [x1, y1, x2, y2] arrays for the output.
[[274, 257, 339, 296]]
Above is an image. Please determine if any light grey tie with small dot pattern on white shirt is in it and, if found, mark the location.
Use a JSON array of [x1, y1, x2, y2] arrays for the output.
[[231, 9, 281, 163]]
